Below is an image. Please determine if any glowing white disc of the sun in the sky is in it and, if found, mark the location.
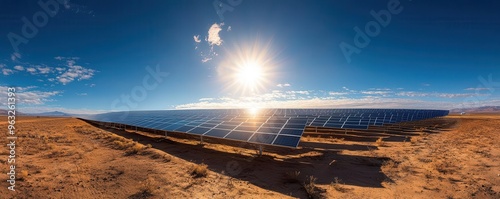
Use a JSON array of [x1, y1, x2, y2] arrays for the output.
[[236, 61, 264, 91]]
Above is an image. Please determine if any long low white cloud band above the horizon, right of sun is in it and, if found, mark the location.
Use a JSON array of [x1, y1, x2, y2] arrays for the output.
[[176, 88, 495, 109]]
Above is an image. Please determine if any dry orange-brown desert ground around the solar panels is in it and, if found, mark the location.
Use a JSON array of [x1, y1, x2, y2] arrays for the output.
[[0, 114, 500, 198]]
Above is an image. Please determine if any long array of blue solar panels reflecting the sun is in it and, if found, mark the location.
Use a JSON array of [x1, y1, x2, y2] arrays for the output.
[[82, 109, 448, 147]]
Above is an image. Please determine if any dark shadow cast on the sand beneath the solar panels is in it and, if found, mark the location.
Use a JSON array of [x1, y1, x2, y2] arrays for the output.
[[84, 123, 391, 198]]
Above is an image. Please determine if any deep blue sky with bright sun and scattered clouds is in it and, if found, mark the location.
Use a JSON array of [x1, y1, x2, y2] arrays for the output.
[[0, 0, 500, 113]]
